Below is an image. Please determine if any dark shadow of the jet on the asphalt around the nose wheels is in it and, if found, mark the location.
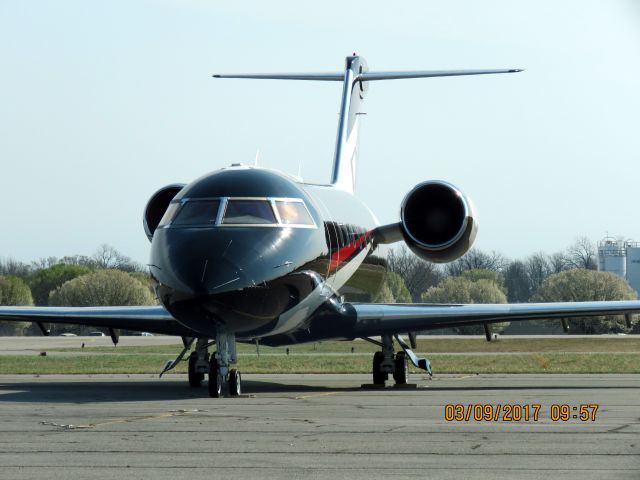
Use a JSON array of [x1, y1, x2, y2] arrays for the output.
[[0, 379, 360, 404]]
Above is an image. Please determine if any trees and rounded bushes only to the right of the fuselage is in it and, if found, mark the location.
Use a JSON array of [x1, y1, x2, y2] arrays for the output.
[[378, 237, 637, 334]]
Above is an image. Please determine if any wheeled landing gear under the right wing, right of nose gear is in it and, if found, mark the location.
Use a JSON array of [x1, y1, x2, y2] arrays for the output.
[[365, 335, 431, 386]]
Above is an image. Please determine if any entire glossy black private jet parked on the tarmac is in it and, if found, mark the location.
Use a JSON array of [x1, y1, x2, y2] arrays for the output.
[[0, 54, 640, 397]]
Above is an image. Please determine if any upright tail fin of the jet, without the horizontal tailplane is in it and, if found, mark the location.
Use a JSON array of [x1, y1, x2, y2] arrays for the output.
[[331, 55, 368, 193]]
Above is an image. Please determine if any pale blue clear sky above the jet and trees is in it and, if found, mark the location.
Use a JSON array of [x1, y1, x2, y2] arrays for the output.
[[0, 0, 640, 263]]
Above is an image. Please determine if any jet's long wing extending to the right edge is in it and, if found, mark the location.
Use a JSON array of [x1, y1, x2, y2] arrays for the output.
[[344, 300, 640, 337]]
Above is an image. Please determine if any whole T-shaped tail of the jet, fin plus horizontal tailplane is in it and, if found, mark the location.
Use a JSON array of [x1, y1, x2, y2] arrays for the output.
[[214, 54, 522, 193]]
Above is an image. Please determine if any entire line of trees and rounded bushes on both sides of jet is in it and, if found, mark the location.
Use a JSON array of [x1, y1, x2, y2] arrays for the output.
[[0, 237, 637, 335]]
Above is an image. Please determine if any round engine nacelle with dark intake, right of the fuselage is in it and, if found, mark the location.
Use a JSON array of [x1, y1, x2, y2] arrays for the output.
[[400, 180, 477, 263]]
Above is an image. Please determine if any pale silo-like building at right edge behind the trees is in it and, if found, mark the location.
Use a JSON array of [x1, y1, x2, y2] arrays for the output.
[[598, 237, 640, 293]]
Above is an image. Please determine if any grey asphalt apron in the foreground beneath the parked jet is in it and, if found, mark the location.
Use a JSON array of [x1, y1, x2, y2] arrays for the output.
[[0, 375, 640, 480]]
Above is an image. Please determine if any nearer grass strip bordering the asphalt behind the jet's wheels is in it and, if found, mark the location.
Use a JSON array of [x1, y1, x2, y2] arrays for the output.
[[0, 353, 640, 375]]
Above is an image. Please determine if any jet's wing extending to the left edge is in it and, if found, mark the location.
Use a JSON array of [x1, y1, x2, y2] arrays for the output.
[[0, 305, 195, 336]]
